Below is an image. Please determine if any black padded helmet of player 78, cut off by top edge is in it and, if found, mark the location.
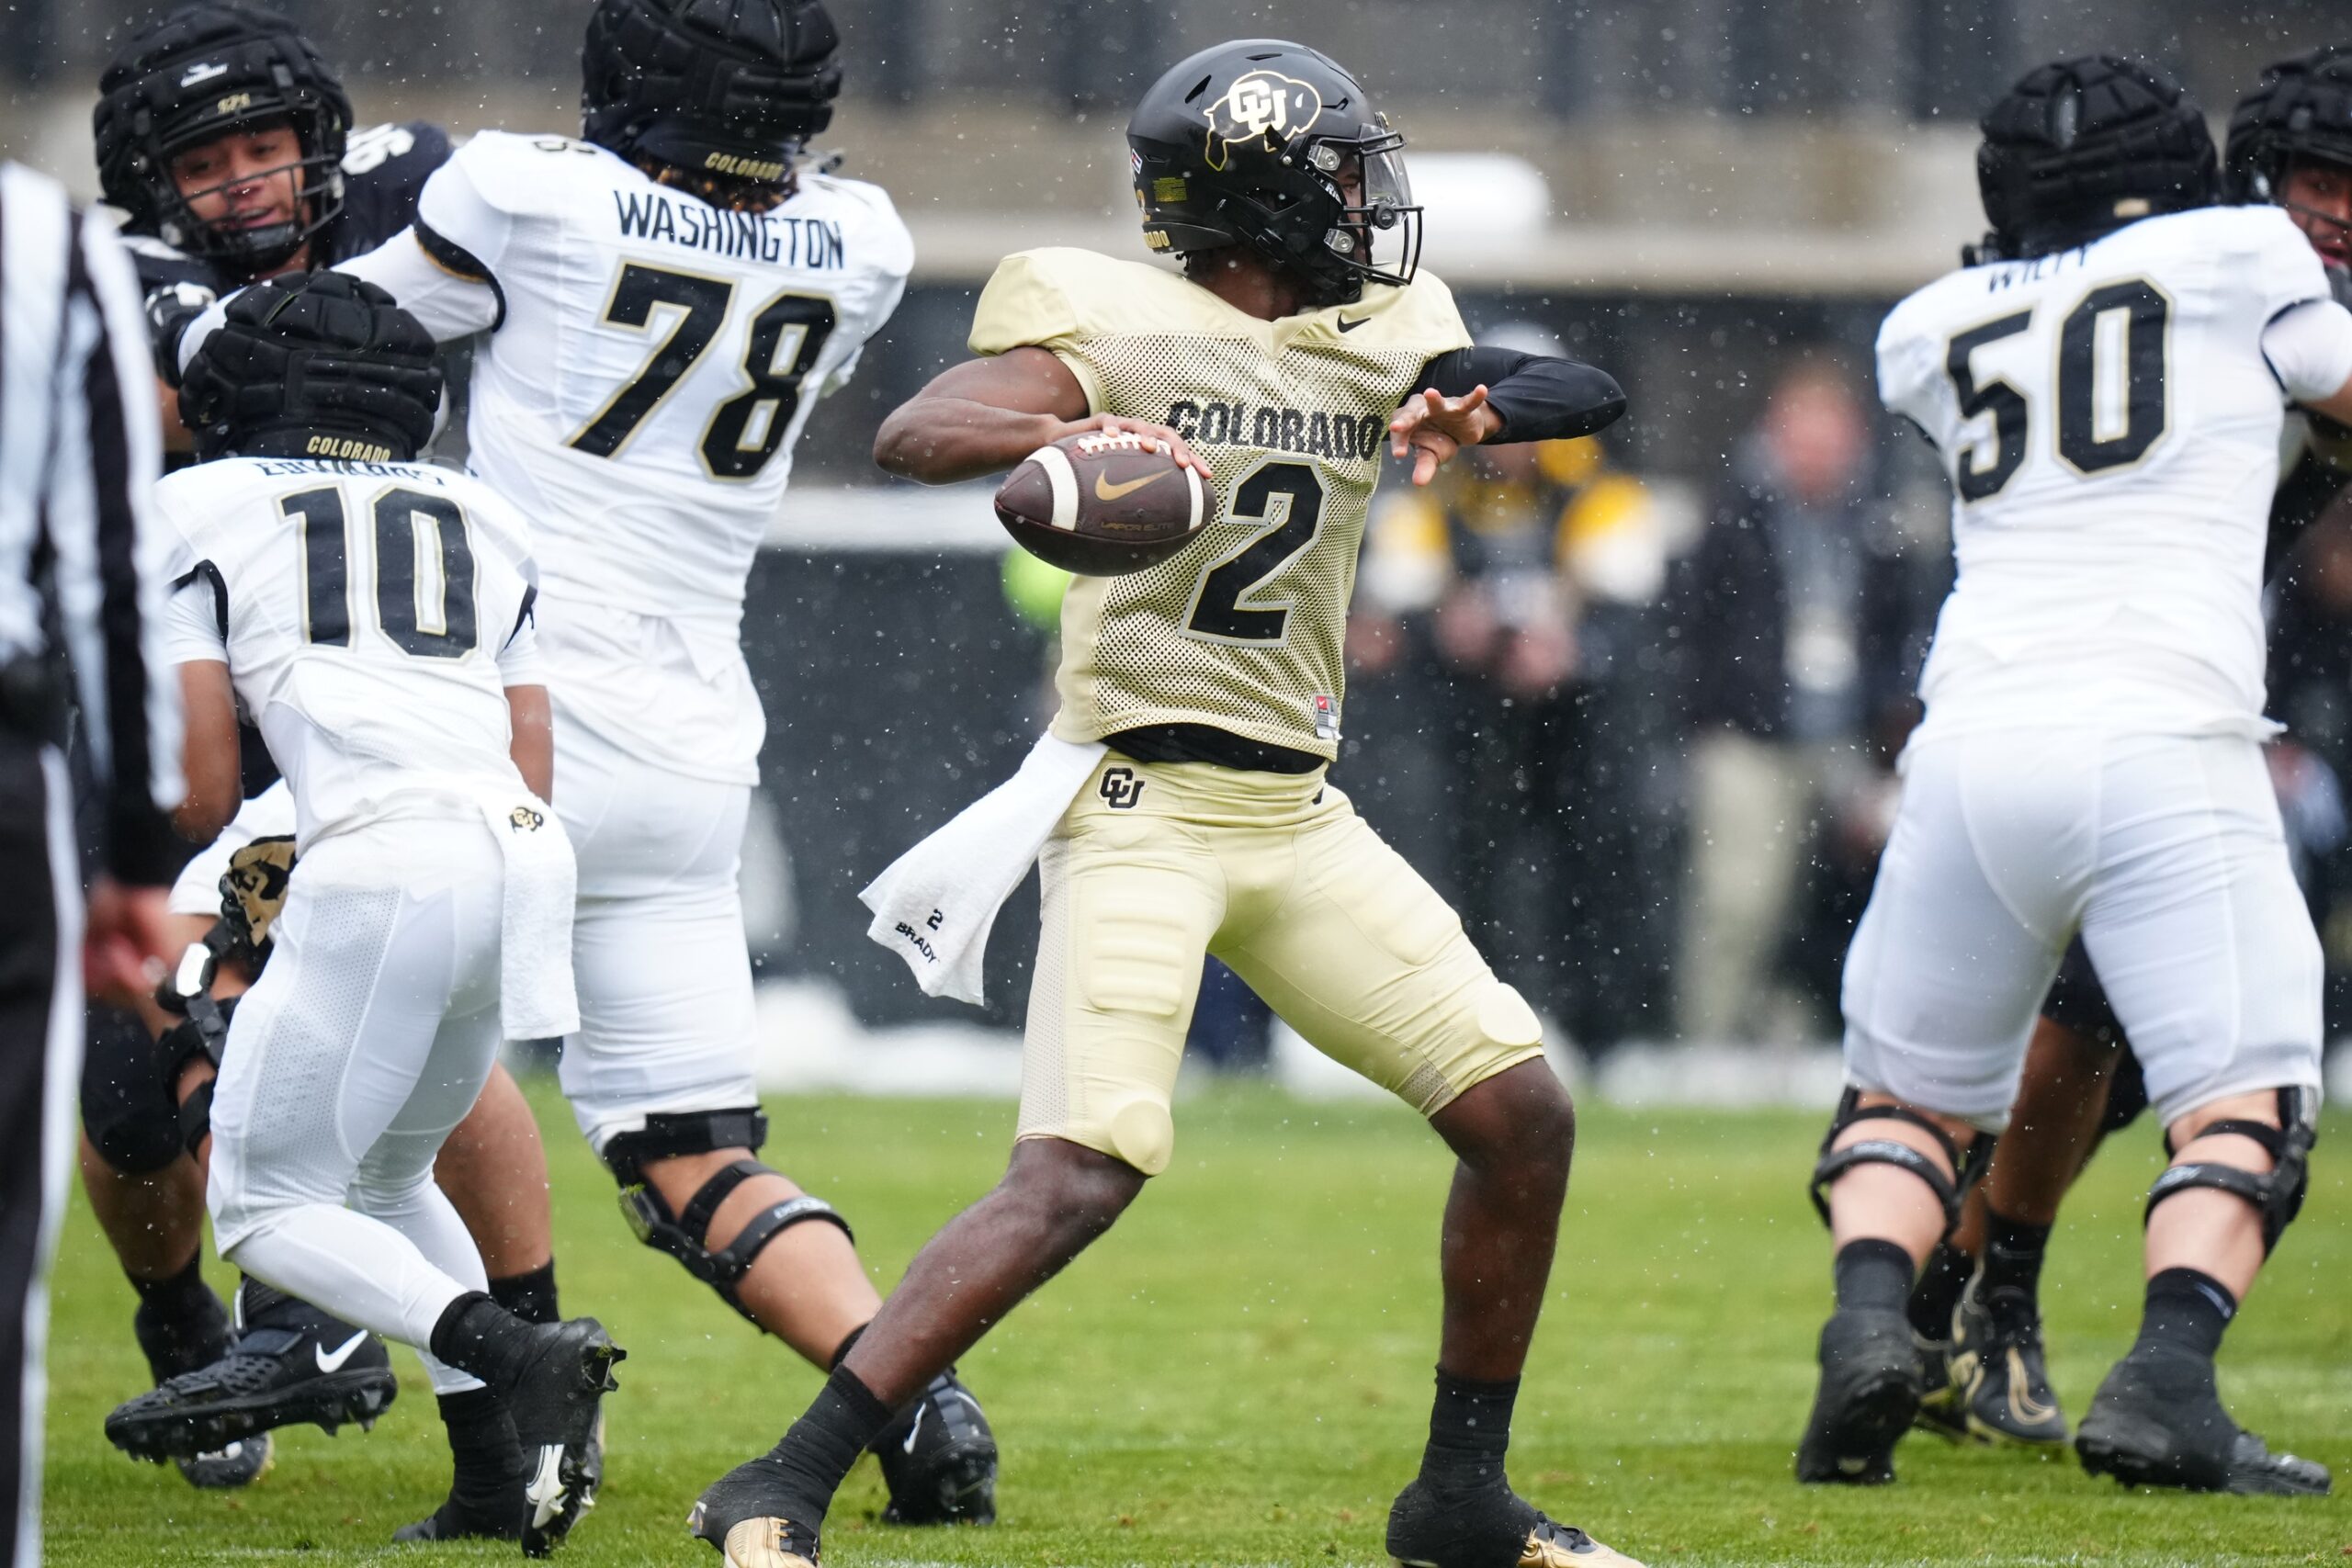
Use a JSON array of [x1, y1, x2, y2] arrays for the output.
[[581, 0, 842, 186]]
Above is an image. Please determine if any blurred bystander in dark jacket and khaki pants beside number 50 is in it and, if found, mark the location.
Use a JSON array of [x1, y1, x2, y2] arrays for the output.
[[1670, 357, 1927, 1042]]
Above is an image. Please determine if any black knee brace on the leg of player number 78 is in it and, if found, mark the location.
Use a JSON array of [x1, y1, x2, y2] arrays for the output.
[[605, 1110, 856, 1325]]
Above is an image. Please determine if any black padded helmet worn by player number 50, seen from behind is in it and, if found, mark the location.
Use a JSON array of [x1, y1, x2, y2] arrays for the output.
[[1966, 54, 2221, 264]]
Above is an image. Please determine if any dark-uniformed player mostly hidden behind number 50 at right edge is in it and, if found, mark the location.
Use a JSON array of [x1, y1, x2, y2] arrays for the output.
[[1910, 45, 2352, 1443]]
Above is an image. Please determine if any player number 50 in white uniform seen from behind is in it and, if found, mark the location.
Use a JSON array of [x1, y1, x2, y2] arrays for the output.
[[1797, 56, 2352, 1495]]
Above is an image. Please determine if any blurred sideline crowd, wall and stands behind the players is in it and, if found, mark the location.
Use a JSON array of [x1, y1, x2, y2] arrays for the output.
[[14, 0, 2352, 1067]]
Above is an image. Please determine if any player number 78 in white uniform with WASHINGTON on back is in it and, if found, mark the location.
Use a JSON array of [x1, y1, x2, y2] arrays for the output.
[[181, 0, 997, 1523]]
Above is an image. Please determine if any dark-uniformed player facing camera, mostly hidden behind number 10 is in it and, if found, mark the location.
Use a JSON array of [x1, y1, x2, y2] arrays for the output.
[[83, 0, 573, 1485]]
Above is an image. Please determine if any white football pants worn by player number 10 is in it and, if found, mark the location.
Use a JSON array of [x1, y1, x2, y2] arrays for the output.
[[209, 818, 503, 1394]]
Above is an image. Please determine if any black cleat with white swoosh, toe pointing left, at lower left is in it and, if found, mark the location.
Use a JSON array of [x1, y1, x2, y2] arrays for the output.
[[106, 1281, 400, 1474]]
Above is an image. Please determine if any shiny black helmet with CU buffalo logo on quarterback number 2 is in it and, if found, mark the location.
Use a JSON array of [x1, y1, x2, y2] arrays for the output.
[[1126, 38, 1420, 306]]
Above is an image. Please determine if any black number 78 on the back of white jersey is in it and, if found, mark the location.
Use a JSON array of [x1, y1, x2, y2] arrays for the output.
[[570, 261, 835, 479]]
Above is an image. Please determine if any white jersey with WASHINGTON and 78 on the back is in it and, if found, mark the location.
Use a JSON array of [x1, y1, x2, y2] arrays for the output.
[[350, 131, 915, 783]]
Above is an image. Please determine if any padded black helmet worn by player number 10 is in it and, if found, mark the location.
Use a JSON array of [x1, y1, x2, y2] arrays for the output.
[[179, 273, 442, 461]]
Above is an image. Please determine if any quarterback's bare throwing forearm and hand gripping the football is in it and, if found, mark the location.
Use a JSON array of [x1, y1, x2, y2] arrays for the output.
[[875, 348, 1209, 484]]
